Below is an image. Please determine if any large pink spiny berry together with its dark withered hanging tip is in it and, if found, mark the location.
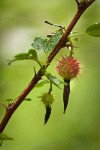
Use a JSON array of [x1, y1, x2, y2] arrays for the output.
[[56, 56, 80, 113]]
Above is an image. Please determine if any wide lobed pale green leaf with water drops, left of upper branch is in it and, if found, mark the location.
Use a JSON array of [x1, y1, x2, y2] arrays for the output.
[[31, 29, 63, 53]]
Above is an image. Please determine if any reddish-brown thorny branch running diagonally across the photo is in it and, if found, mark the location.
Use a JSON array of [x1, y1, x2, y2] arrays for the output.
[[0, 0, 95, 133]]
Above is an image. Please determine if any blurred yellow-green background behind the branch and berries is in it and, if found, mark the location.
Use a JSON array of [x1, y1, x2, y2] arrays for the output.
[[0, 0, 100, 150]]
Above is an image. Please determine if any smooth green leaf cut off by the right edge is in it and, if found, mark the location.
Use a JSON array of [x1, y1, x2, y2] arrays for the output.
[[85, 23, 100, 37]]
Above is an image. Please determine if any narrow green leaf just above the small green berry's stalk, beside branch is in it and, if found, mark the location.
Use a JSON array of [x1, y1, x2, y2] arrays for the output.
[[46, 73, 61, 89]]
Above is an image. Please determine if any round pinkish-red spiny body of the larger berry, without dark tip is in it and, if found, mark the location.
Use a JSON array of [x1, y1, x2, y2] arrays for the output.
[[56, 56, 80, 80]]
